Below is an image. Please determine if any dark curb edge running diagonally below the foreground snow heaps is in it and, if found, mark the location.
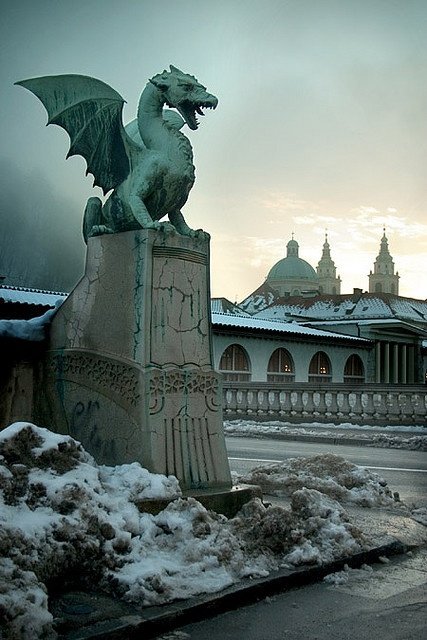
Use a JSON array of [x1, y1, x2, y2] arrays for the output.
[[59, 540, 418, 640]]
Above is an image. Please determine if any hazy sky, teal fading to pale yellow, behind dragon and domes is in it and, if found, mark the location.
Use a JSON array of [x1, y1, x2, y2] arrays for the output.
[[0, 0, 427, 302]]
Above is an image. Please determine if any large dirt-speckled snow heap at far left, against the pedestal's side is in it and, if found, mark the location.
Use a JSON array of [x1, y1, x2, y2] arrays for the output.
[[0, 423, 180, 638]]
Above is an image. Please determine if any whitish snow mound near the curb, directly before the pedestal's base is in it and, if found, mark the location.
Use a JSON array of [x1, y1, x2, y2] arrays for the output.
[[109, 498, 270, 604]]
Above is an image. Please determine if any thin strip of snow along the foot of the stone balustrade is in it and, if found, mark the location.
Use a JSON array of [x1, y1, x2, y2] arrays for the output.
[[224, 420, 427, 451]]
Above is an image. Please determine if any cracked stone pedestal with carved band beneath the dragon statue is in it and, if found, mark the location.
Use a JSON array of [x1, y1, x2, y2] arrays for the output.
[[36, 230, 231, 489]]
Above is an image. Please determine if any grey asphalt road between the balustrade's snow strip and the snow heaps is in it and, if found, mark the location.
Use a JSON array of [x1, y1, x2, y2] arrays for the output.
[[226, 437, 427, 504]]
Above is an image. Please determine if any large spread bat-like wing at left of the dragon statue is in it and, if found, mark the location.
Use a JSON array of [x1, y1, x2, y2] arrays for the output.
[[15, 74, 130, 195]]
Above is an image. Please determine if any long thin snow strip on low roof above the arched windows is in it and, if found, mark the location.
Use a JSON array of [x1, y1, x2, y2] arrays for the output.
[[212, 313, 367, 343]]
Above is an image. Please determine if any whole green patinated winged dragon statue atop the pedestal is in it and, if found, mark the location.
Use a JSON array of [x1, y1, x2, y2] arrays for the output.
[[16, 65, 218, 242]]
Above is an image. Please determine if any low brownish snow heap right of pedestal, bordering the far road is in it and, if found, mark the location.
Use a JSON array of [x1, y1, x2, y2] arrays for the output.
[[239, 454, 394, 507]]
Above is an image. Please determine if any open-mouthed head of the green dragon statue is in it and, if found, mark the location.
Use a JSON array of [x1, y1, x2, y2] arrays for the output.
[[150, 65, 218, 130]]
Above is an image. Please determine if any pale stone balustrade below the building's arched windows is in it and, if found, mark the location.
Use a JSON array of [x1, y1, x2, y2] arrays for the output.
[[223, 381, 427, 426]]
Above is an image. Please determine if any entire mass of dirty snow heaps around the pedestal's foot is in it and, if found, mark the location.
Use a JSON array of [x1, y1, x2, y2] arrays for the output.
[[0, 423, 424, 640]]
